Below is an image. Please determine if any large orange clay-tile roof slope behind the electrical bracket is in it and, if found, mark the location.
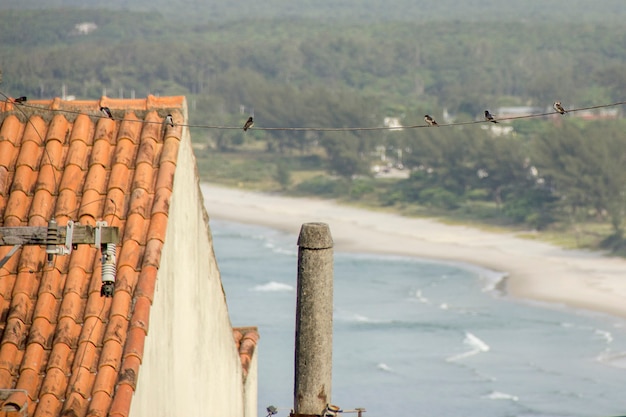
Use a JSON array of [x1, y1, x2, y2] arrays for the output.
[[0, 96, 186, 416]]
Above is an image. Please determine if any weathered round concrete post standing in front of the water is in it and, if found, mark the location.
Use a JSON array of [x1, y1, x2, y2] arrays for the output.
[[294, 223, 333, 416]]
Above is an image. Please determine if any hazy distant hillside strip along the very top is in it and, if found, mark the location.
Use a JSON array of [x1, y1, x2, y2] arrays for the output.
[[0, 0, 626, 22]]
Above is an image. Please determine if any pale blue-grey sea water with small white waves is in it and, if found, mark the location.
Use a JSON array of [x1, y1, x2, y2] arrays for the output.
[[210, 219, 626, 417]]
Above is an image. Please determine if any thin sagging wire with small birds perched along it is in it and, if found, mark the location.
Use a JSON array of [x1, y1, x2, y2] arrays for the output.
[[0, 91, 626, 132]]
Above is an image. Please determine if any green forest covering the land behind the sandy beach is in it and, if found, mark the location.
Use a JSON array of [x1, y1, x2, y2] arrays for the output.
[[0, 4, 626, 254]]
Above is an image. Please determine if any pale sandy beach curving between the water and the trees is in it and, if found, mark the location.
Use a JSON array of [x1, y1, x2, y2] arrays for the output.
[[201, 183, 626, 318]]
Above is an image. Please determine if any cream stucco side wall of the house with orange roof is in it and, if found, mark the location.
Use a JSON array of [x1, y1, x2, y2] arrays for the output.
[[130, 115, 257, 417]]
